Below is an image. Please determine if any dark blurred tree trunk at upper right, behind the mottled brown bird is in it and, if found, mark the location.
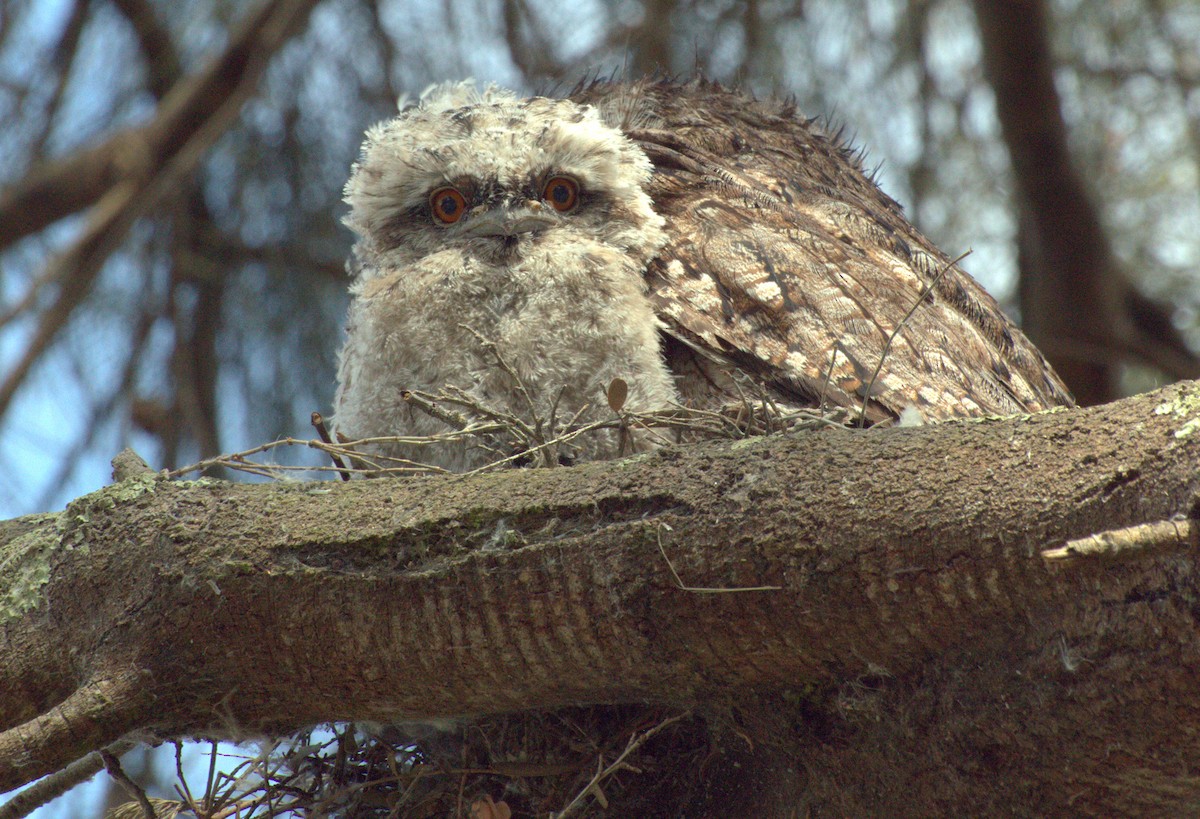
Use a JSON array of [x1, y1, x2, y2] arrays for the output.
[[974, 0, 1200, 405]]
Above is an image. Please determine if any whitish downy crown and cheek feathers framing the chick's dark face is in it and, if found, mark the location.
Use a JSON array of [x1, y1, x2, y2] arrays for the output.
[[344, 83, 665, 275]]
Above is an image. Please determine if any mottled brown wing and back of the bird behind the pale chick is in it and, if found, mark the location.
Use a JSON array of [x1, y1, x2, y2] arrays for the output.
[[578, 82, 1070, 422]]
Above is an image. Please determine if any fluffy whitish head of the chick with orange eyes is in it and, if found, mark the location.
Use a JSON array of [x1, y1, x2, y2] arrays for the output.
[[346, 82, 665, 276]]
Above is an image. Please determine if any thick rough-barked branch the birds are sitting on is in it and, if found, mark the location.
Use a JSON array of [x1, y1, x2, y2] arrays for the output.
[[0, 384, 1200, 815]]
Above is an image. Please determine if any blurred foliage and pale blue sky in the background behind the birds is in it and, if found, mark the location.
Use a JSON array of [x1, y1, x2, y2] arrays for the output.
[[0, 0, 1200, 515]]
